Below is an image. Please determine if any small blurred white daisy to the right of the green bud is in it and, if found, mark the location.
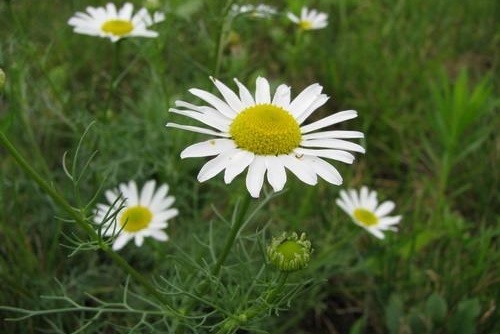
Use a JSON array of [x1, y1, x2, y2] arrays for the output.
[[336, 186, 402, 239]]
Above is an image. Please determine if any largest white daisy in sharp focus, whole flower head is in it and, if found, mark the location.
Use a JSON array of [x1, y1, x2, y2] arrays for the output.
[[167, 77, 365, 197]]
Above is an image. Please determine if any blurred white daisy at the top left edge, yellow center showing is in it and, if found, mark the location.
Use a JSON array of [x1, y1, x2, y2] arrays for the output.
[[68, 2, 165, 42]]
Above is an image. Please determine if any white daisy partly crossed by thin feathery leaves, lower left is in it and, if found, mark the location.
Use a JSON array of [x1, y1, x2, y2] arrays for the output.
[[94, 180, 179, 250]]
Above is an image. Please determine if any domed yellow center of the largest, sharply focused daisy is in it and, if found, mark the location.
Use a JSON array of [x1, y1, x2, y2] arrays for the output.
[[229, 104, 302, 155]]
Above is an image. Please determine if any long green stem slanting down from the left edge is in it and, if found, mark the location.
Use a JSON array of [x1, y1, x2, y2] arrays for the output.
[[0, 131, 172, 305]]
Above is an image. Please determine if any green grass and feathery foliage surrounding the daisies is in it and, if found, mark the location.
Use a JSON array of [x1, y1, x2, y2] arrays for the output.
[[0, 0, 500, 334]]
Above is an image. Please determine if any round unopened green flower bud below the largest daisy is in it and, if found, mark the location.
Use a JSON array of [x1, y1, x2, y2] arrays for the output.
[[267, 232, 312, 272]]
